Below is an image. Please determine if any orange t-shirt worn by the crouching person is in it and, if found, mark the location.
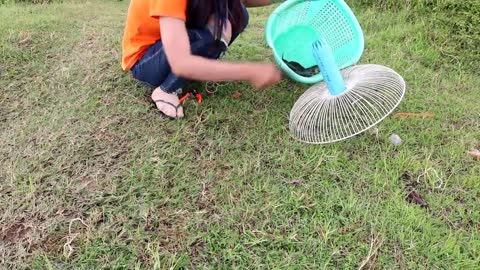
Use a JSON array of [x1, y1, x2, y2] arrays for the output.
[[122, 0, 187, 70]]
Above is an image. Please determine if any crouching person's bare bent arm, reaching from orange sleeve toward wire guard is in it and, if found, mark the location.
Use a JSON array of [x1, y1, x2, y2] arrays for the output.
[[160, 17, 281, 88]]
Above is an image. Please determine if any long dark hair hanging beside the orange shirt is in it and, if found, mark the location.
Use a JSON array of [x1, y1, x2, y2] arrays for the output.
[[187, 0, 245, 39]]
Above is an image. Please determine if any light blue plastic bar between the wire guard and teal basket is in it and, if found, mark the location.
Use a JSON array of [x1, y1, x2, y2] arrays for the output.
[[312, 40, 346, 96]]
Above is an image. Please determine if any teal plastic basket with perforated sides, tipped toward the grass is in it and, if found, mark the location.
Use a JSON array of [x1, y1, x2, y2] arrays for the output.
[[265, 0, 364, 84]]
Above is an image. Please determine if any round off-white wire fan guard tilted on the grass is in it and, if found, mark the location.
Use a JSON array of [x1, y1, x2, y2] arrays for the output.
[[289, 65, 406, 144]]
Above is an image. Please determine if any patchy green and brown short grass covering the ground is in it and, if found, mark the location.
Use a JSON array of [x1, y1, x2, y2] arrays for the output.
[[0, 0, 480, 269]]
